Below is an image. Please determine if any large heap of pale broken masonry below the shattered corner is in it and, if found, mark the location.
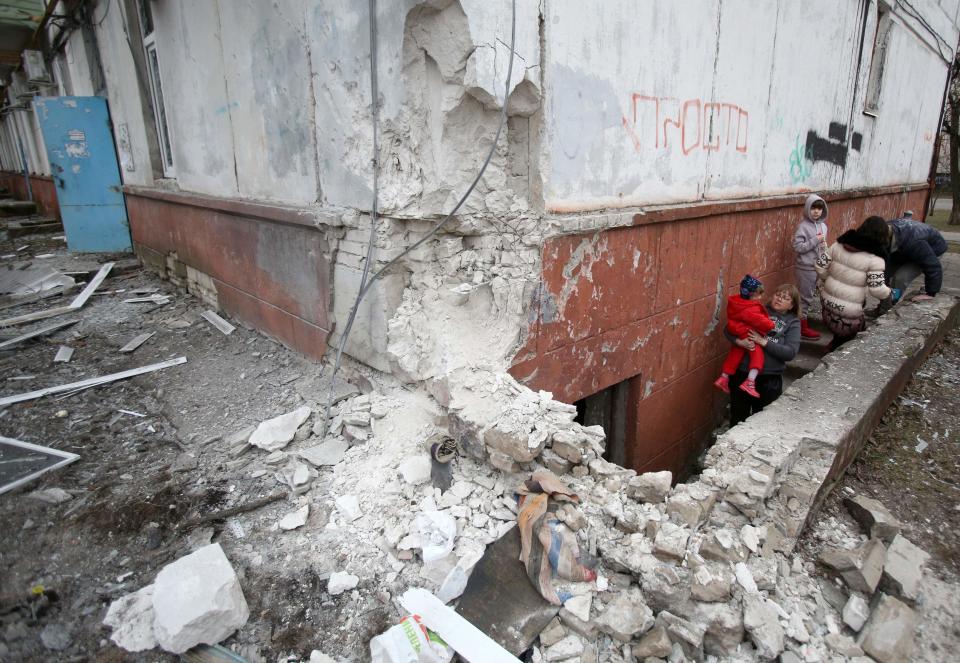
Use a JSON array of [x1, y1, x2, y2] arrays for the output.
[[101, 369, 922, 661]]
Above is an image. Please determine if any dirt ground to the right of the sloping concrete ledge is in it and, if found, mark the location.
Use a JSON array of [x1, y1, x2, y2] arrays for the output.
[[798, 329, 960, 663]]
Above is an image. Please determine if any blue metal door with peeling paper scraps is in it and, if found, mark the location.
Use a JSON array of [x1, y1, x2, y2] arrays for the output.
[[33, 97, 131, 251]]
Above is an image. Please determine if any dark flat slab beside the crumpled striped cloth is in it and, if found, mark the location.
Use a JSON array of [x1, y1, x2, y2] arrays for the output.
[[457, 527, 559, 656]]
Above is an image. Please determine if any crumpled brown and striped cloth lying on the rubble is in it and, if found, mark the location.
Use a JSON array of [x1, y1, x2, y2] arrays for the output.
[[517, 470, 597, 605]]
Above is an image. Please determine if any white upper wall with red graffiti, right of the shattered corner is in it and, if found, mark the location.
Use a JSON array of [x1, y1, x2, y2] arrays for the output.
[[541, 0, 958, 211]]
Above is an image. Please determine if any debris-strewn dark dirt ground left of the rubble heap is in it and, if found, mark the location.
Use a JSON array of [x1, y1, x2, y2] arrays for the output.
[[0, 231, 389, 662]]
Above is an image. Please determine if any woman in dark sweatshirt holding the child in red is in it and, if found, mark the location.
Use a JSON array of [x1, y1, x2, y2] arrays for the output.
[[724, 282, 800, 426]]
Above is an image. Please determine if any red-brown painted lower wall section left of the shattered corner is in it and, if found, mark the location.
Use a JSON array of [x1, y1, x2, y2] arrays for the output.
[[126, 191, 330, 359]]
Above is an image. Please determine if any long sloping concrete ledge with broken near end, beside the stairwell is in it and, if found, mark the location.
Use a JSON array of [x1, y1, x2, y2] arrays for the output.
[[702, 295, 960, 553]]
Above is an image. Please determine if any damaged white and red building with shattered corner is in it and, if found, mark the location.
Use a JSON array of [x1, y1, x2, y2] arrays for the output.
[[0, 0, 960, 476]]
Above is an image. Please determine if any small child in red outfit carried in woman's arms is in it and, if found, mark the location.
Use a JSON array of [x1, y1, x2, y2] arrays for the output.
[[713, 274, 774, 398]]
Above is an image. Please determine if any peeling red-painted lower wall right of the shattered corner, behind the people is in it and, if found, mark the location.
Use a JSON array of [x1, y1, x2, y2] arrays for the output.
[[511, 188, 927, 474]]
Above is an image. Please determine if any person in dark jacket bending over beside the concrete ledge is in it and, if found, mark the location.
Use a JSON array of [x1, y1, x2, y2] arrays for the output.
[[885, 218, 947, 303]]
